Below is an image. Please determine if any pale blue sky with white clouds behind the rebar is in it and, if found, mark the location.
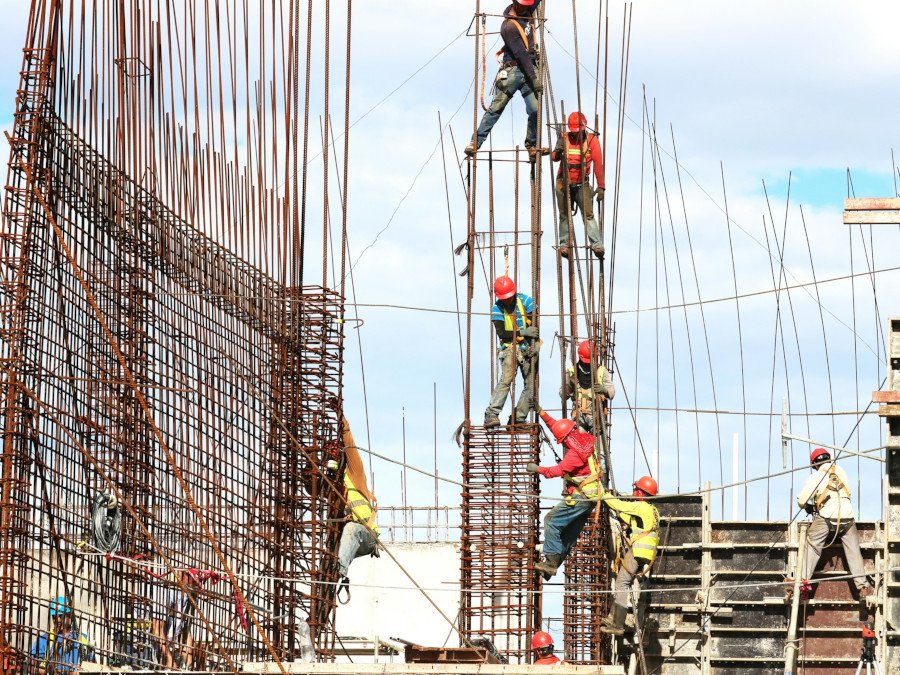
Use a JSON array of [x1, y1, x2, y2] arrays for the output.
[[0, 0, 900, 532]]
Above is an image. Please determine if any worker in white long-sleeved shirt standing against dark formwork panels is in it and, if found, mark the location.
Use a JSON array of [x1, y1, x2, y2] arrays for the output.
[[797, 448, 875, 598]]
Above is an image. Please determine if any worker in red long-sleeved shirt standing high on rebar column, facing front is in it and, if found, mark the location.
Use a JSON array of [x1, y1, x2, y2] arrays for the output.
[[551, 112, 606, 258]]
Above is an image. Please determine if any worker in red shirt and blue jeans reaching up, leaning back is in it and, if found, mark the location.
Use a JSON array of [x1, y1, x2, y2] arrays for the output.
[[526, 410, 602, 579]]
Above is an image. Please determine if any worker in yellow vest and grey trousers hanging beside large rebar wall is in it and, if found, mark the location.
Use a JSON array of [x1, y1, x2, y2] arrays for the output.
[[338, 417, 381, 603]]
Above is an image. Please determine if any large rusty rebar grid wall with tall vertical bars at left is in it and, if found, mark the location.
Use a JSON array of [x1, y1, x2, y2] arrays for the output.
[[0, 0, 349, 673]]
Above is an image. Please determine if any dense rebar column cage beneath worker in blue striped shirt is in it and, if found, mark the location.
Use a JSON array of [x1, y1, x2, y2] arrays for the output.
[[460, 424, 541, 663]]
